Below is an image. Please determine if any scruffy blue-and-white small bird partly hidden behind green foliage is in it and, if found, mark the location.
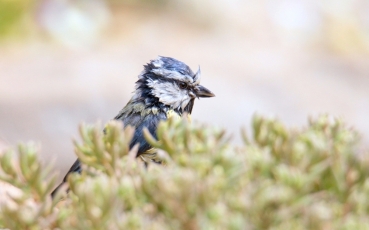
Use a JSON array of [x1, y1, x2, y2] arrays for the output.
[[51, 56, 215, 197]]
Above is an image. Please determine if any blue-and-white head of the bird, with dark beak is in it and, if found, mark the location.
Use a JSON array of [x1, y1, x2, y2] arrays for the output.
[[136, 56, 215, 113]]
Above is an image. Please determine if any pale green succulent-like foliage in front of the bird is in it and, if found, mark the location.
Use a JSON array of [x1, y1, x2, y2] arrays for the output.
[[0, 116, 369, 229]]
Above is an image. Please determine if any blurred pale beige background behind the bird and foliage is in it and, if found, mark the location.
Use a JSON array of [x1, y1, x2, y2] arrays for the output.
[[0, 0, 369, 181]]
